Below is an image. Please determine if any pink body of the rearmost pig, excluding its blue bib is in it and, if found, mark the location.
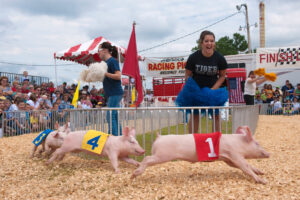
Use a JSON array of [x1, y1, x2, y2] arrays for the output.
[[30, 123, 71, 158]]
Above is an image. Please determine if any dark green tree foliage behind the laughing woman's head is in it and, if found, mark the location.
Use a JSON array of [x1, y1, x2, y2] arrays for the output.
[[192, 33, 248, 56]]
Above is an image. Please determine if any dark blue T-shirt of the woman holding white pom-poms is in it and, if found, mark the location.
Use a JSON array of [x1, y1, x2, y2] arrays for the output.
[[103, 57, 123, 97]]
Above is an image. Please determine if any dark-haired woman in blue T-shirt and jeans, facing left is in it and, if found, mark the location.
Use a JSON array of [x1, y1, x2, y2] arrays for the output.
[[98, 42, 123, 135]]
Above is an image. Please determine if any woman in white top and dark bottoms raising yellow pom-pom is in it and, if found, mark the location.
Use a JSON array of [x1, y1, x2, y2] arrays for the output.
[[244, 71, 266, 105]]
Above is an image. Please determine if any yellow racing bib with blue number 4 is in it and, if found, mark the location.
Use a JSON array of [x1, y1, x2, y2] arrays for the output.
[[81, 130, 108, 154]]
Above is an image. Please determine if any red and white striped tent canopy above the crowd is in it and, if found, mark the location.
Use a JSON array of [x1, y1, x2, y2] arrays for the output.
[[54, 37, 126, 66]]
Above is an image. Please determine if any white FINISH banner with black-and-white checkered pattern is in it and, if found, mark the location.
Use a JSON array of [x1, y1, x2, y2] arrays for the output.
[[256, 46, 300, 69]]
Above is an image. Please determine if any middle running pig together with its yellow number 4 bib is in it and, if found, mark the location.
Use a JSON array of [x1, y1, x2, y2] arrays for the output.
[[46, 127, 145, 173]]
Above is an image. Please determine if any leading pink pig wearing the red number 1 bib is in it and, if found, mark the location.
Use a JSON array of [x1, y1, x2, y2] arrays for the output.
[[132, 126, 270, 184]]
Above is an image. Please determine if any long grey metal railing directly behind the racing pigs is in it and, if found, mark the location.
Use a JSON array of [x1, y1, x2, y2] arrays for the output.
[[1, 106, 259, 137]]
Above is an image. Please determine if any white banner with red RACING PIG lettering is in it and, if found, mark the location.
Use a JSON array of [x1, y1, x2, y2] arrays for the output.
[[143, 56, 188, 77]]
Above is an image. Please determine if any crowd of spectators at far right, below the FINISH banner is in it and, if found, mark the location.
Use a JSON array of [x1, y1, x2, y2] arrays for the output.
[[255, 80, 300, 115]]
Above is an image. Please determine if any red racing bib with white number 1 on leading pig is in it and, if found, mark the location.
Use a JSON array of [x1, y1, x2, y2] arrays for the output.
[[193, 132, 222, 162]]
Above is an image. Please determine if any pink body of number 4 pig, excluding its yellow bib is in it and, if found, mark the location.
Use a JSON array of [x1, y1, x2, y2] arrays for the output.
[[46, 127, 145, 173]]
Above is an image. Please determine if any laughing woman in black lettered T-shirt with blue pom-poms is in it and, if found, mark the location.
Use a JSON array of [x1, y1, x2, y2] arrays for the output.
[[176, 31, 227, 133]]
